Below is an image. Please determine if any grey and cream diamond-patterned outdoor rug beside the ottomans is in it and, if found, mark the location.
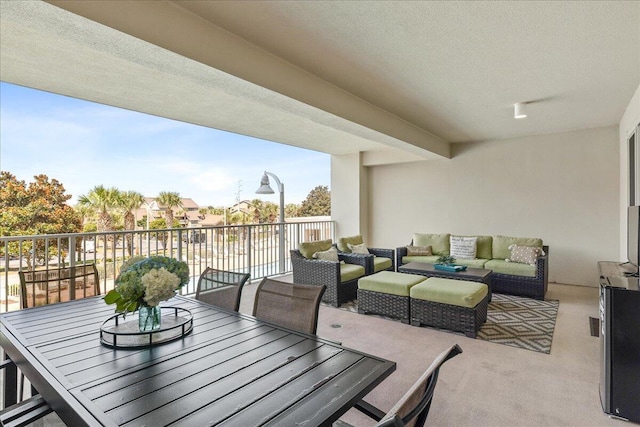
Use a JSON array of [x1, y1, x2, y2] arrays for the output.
[[328, 293, 559, 354]]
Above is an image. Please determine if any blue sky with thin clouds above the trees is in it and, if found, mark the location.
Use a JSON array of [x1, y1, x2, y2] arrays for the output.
[[0, 82, 330, 206]]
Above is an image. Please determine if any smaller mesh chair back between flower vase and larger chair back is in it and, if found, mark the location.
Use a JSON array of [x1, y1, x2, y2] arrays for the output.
[[196, 267, 250, 311]]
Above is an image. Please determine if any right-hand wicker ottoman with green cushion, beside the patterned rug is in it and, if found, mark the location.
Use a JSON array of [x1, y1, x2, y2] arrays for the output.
[[409, 277, 489, 338]]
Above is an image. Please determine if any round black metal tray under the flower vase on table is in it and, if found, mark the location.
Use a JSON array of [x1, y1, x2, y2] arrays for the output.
[[100, 307, 193, 348]]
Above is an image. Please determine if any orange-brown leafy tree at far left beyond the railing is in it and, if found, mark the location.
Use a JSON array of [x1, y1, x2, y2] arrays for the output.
[[0, 171, 82, 269]]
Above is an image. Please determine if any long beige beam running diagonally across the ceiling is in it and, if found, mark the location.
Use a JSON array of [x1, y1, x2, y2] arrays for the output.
[[47, 0, 450, 158]]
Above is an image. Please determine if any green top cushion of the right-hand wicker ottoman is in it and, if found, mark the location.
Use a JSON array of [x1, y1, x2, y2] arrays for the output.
[[409, 277, 489, 308]]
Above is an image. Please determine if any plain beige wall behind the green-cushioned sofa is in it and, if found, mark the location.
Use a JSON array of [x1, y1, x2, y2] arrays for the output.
[[358, 126, 620, 286]]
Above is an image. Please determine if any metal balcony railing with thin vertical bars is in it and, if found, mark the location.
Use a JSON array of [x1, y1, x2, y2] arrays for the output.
[[0, 221, 335, 312]]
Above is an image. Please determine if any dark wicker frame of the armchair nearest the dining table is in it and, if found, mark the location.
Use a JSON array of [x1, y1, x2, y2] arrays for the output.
[[291, 249, 367, 307]]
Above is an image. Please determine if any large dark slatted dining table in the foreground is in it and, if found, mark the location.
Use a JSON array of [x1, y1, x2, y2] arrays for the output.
[[0, 296, 396, 427]]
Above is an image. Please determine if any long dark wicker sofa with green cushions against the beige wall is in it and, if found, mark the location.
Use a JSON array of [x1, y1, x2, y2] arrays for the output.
[[396, 233, 549, 300]]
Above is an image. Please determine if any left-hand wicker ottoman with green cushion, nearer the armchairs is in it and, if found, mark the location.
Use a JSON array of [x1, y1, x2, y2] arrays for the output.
[[358, 271, 427, 323]]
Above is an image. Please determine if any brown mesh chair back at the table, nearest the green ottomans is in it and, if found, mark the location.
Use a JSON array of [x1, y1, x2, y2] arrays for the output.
[[253, 277, 326, 335]]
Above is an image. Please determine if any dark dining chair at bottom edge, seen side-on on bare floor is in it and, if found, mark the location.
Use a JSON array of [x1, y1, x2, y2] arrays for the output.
[[334, 344, 462, 427]]
